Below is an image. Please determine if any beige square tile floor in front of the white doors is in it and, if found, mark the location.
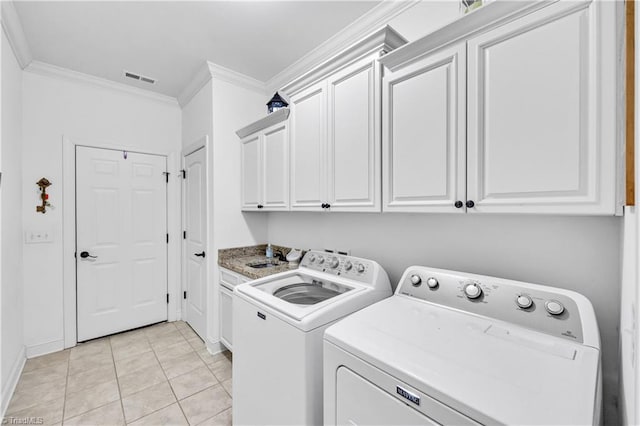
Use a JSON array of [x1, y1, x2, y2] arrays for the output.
[[5, 321, 231, 425]]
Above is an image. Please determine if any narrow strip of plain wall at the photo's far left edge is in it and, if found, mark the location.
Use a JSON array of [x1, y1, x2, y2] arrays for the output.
[[0, 30, 24, 413]]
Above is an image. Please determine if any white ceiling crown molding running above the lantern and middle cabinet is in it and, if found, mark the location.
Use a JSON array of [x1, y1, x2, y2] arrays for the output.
[[266, 0, 421, 93]]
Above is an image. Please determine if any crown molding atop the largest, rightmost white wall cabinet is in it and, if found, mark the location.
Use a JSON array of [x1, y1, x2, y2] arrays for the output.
[[380, 0, 564, 71]]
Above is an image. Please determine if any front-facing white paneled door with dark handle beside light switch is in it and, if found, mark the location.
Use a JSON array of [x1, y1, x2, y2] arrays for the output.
[[76, 147, 167, 341]]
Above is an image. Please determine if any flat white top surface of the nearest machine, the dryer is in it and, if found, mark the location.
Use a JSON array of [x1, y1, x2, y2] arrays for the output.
[[325, 296, 600, 425]]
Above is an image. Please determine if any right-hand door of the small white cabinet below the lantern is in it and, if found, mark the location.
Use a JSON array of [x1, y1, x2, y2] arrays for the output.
[[261, 123, 289, 210]]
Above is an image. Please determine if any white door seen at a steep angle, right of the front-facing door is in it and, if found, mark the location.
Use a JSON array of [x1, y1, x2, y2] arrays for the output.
[[183, 147, 210, 340]]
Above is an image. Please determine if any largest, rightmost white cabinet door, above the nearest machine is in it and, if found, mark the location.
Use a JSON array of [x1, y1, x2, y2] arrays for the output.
[[467, 1, 616, 214]]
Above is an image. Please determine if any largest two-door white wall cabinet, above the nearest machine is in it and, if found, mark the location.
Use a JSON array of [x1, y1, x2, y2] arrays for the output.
[[382, 1, 621, 215]]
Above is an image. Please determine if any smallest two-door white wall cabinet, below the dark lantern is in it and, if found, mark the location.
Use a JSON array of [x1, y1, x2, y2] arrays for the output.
[[241, 116, 289, 211]]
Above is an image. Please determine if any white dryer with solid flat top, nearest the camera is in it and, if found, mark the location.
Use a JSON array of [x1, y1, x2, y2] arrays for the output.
[[324, 266, 601, 426]]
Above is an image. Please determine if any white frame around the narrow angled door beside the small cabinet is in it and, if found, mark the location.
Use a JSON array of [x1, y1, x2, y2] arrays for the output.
[[180, 135, 212, 332]]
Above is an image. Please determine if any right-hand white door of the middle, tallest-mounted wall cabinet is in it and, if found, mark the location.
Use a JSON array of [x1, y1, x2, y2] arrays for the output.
[[327, 59, 381, 211]]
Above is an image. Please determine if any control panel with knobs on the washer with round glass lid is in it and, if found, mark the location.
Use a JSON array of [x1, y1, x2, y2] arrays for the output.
[[300, 250, 375, 283]]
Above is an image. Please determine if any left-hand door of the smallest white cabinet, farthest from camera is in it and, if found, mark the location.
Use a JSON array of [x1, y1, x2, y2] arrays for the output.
[[242, 134, 262, 210]]
